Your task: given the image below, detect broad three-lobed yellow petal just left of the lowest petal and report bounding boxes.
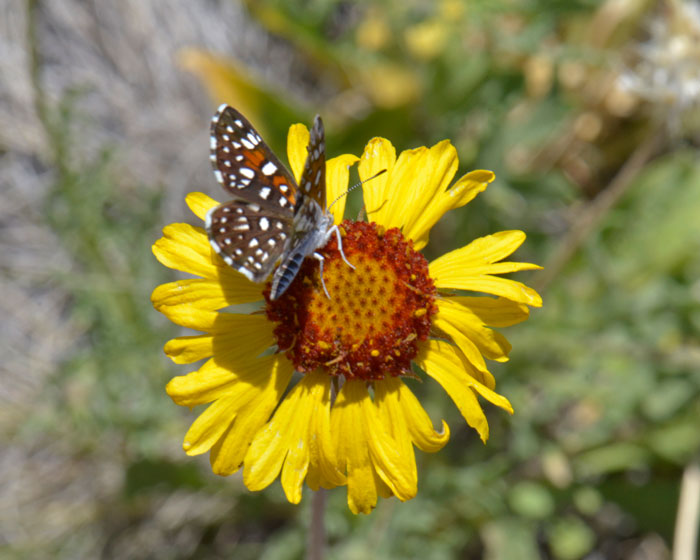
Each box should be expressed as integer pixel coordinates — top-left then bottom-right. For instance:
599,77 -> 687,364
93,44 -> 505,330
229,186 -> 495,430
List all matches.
243,372 -> 345,504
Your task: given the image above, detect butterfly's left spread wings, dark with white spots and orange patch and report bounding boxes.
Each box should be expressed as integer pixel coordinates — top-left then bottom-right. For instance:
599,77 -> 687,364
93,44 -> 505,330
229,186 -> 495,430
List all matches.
206,105 -> 297,282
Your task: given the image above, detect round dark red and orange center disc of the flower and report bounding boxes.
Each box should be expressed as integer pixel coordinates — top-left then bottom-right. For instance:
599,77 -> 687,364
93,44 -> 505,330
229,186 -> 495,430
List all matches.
264,220 -> 437,380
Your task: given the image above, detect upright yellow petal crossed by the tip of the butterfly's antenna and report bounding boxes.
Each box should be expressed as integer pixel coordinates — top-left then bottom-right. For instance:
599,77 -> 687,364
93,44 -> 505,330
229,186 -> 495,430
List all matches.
358,138 -> 396,224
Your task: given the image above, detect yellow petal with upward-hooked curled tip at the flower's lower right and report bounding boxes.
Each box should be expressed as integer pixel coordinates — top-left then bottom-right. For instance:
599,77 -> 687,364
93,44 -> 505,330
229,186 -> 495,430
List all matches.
374,377 -> 450,453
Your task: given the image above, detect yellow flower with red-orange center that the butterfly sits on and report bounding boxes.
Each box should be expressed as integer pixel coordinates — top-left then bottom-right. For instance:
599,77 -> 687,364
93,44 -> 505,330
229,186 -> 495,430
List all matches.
152,121 -> 541,513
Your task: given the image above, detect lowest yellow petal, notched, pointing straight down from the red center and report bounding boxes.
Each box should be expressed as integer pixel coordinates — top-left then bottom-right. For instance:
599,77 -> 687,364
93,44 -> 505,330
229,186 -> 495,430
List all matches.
331,380 -> 416,513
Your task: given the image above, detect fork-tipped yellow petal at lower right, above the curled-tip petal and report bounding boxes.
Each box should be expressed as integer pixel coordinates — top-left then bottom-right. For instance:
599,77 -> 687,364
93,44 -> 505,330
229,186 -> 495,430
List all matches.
415,340 -> 513,442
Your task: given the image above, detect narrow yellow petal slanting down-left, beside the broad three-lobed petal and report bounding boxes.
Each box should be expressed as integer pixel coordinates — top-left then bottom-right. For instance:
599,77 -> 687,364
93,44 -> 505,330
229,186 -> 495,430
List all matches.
210,355 -> 294,476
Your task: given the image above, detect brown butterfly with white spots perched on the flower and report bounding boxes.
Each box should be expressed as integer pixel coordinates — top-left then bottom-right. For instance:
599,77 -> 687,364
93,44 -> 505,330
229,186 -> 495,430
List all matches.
205,104 -> 355,300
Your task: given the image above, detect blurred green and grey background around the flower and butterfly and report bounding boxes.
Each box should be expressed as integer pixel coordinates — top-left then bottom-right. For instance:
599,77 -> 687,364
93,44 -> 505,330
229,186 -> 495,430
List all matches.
0,0 -> 700,560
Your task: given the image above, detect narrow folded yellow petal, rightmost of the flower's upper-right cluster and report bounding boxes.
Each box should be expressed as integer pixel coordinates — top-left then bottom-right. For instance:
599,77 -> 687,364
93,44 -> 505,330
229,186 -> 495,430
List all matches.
404,170 -> 495,250
